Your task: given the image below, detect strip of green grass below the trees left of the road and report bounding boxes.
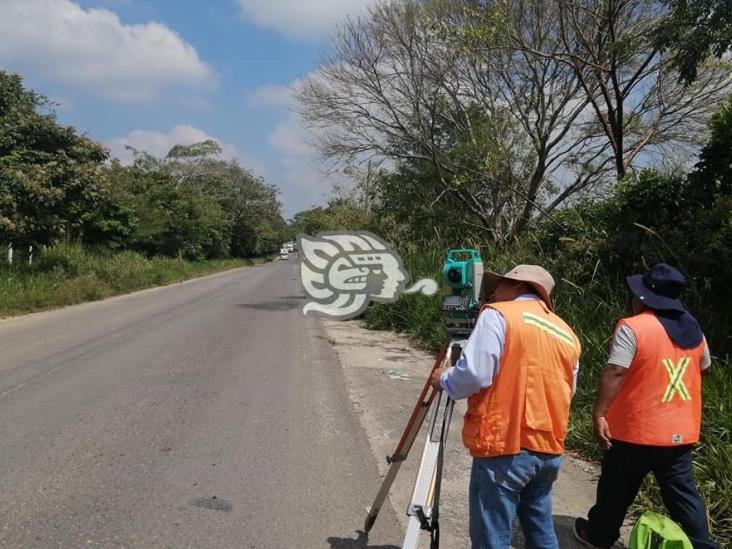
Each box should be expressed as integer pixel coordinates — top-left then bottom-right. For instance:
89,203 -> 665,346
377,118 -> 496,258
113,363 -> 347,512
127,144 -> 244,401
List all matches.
0,244 -> 269,317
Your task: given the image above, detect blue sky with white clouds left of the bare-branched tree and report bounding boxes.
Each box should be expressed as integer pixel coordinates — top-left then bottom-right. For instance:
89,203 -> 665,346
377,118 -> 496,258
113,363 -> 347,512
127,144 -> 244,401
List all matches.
0,0 -> 373,217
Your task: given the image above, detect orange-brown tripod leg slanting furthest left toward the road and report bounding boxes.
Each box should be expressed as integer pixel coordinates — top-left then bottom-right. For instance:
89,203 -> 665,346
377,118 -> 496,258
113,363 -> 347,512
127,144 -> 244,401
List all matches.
364,346 -> 448,534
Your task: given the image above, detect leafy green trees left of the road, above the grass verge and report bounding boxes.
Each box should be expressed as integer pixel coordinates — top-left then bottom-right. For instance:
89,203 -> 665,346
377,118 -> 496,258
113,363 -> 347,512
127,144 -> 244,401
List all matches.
0,71 -> 286,261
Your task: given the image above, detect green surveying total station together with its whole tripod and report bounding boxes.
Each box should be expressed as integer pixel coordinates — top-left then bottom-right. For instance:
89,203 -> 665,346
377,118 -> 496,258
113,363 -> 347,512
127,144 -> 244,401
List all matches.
364,249 -> 483,549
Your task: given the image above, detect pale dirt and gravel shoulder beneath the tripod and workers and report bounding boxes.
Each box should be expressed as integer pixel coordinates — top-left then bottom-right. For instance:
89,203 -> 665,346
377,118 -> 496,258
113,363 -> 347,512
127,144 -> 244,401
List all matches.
323,320 -> 632,549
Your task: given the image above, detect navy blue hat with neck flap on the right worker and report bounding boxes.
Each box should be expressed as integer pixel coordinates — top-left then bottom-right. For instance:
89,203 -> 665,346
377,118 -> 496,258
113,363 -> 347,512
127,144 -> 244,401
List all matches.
626,263 -> 704,349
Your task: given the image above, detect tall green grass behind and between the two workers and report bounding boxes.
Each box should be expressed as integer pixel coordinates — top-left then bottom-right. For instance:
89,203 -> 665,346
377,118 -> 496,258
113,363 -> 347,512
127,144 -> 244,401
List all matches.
364,243 -> 732,547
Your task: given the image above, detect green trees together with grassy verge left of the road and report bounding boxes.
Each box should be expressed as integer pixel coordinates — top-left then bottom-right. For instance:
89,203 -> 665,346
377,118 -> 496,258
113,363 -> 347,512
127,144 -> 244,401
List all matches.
0,71 -> 289,316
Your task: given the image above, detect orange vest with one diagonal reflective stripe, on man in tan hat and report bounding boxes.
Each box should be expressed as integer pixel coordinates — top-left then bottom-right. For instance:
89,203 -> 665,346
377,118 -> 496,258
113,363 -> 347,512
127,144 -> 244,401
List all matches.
462,300 -> 581,457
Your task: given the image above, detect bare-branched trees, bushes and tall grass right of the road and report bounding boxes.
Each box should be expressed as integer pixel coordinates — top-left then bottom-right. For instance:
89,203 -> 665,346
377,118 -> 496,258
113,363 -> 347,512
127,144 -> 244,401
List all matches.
293,0 -> 732,547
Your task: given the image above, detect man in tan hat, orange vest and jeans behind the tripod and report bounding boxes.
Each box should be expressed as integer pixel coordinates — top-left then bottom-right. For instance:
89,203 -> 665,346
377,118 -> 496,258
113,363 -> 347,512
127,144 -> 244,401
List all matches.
432,265 -> 580,549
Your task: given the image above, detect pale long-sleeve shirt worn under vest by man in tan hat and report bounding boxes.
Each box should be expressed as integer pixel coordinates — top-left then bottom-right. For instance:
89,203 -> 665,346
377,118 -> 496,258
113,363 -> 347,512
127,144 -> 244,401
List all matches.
440,294 -> 579,400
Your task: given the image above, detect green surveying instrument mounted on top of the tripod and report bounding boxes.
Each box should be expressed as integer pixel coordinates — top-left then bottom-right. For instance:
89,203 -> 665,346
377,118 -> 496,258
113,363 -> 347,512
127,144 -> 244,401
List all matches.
442,248 -> 483,336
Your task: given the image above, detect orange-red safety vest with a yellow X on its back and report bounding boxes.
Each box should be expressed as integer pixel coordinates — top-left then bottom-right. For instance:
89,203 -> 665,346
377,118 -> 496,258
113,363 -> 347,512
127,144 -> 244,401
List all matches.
607,311 -> 704,446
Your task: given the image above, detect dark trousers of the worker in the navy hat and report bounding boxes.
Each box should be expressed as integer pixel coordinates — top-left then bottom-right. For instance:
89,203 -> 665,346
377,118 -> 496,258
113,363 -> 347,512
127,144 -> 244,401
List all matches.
588,440 -> 718,549
